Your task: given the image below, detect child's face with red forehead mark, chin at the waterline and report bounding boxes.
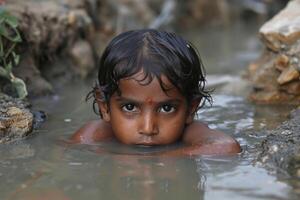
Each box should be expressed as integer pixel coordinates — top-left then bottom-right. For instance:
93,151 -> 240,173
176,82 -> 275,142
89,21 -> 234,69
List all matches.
99,72 -> 197,145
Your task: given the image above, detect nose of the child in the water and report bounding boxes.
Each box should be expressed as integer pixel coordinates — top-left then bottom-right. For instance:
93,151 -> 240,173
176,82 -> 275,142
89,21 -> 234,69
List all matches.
139,112 -> 158,136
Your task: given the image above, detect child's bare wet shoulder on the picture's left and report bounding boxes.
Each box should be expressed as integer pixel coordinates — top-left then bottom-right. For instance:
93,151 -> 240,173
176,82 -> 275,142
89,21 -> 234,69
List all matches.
70,120 -> 113,144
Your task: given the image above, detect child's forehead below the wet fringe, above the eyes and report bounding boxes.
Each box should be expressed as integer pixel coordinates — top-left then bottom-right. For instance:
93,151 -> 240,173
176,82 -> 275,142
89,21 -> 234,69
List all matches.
115,72 -> 184,101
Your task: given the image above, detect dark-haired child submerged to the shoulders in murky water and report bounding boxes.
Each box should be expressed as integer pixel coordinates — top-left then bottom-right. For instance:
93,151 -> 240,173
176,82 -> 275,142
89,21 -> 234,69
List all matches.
71,29 -> 241,155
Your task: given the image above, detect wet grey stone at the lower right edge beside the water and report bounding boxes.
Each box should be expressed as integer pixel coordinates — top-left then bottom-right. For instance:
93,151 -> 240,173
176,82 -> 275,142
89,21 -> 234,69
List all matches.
257,108 -> 300,180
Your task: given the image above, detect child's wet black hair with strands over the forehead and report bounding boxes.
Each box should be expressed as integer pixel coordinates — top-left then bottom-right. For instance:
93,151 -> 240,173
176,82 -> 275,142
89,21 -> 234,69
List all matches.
87,29 -> 212,116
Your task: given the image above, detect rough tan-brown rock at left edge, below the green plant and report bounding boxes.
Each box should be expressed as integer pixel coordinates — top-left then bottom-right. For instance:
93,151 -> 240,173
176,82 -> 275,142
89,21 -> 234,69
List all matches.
0,93 -> 33,143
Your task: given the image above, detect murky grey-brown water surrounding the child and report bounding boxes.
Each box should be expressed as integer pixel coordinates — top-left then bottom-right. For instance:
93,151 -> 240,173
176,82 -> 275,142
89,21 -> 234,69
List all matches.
0,21 -> 297,200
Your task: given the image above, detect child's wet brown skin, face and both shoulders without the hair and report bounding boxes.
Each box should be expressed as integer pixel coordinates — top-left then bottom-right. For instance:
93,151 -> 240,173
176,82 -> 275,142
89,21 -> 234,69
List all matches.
71,72 -> 241,155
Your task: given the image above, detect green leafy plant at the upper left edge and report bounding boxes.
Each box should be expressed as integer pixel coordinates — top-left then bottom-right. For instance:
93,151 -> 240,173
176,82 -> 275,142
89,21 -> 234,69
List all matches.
0,7 -> 28,99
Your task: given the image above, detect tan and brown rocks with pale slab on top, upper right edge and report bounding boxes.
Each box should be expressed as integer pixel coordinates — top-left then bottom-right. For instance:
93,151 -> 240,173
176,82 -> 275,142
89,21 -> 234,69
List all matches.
249,0 -> 300,105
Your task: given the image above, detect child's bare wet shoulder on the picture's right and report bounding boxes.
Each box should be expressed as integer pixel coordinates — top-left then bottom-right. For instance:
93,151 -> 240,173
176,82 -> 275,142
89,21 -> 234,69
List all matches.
183,121 -> 241,155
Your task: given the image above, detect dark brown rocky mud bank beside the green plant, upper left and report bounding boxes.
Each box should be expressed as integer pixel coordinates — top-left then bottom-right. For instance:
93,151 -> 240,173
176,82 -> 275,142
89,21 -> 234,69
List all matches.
6,0 -> 100,97
